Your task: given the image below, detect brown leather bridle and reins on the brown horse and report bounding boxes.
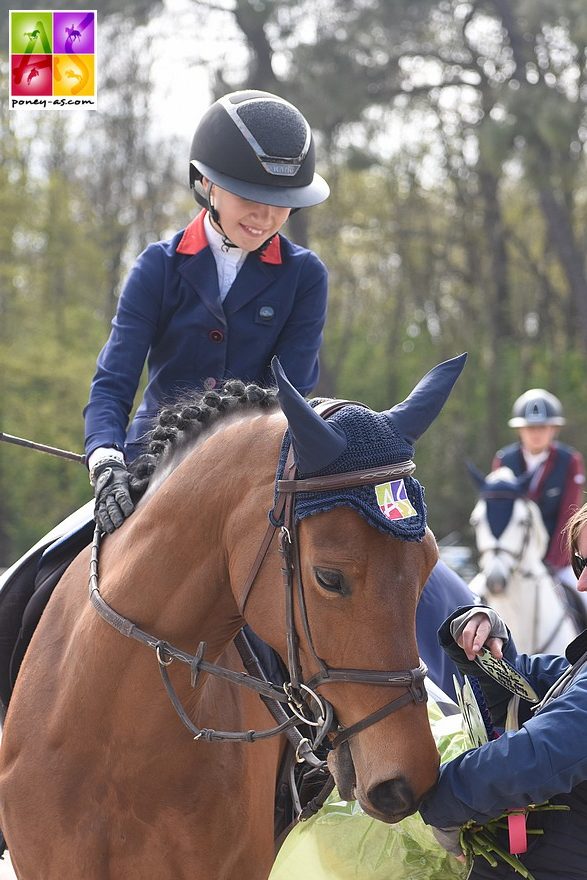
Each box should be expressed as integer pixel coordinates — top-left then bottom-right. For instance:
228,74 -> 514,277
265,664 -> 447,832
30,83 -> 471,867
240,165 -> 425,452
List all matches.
89,400 -> 428,766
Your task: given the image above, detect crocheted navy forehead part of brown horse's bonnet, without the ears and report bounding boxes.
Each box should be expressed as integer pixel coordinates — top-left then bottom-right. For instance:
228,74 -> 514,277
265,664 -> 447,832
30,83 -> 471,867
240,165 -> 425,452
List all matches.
276,408 -> 426,541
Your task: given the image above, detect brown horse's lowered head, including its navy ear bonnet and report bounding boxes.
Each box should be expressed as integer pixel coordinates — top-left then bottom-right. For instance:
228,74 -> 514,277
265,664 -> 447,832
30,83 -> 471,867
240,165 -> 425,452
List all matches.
234,356 -> 465,822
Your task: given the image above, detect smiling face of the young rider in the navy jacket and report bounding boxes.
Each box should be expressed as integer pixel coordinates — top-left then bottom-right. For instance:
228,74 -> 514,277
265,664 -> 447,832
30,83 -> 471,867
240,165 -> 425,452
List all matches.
202,178 -> 290,251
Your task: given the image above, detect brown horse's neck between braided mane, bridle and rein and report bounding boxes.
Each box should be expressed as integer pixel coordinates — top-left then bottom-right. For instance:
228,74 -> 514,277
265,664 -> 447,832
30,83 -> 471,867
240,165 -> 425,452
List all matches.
100,416 -> 279,653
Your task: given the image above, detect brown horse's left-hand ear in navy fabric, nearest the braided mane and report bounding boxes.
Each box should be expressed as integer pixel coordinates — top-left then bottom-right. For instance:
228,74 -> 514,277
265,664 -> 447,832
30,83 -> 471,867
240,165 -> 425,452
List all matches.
271,357 -> 347,474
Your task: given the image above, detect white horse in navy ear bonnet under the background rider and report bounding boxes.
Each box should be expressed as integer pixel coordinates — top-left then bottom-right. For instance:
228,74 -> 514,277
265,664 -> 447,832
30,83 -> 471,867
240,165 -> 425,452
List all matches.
469,467 -> 580,654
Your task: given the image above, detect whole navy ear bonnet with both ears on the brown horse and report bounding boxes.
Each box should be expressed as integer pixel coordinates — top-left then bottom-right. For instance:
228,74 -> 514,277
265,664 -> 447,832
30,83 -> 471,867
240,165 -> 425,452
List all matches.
271,354 -> 467,541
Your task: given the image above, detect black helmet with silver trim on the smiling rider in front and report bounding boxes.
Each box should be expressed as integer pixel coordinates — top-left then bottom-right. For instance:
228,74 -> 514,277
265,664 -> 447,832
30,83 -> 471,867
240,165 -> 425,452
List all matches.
190,90 -> 330,209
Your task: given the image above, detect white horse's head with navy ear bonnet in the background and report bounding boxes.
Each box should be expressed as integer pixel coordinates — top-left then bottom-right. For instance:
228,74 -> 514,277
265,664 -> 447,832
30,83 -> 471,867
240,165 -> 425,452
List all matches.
469,465 -> 548,595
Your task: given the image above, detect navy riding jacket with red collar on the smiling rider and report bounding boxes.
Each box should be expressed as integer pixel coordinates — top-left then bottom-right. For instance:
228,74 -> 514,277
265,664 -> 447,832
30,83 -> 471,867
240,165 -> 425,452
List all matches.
84,211 -> 327,458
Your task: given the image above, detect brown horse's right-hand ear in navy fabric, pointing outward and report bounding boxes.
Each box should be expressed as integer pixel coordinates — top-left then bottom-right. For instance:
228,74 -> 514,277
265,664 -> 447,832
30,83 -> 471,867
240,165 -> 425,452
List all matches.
387,354 -> 467,443
